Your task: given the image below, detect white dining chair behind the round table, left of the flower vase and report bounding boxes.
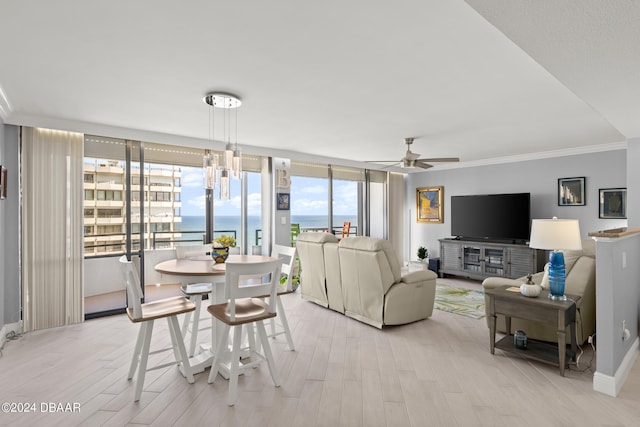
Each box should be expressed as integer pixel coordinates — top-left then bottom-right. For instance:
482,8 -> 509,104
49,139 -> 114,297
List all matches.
176,245 -> 213,357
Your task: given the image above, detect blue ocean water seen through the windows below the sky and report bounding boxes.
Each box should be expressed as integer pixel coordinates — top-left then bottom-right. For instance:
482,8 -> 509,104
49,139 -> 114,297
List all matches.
176,215 -> 358,245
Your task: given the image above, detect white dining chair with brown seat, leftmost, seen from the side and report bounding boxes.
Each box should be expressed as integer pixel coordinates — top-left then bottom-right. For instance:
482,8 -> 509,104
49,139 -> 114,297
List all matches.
120,255 -> 196,402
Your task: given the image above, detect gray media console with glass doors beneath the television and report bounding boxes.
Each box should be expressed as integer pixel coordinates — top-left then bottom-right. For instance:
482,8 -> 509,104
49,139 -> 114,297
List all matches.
440,239 -> 547,280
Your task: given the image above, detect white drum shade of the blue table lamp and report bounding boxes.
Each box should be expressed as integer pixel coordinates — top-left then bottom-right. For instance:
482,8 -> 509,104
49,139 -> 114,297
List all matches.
529,218 -> 582,250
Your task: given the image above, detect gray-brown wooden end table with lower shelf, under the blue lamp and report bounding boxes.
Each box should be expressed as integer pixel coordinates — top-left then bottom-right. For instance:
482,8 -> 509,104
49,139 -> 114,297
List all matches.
485,286 -> 581,376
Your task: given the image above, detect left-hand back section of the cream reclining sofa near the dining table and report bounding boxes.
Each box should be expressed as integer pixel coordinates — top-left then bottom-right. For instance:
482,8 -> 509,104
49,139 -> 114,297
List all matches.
296,233 -> 344,312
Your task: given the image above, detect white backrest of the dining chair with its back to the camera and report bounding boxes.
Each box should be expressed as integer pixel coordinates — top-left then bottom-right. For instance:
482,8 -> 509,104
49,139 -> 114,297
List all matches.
224,259 -> 282,321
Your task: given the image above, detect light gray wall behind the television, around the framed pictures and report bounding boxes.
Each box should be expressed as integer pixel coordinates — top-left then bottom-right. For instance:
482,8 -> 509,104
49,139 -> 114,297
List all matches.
404,150 -> 627,260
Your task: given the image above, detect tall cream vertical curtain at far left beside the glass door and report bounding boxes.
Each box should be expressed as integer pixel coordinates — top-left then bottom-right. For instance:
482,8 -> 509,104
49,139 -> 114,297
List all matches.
21,127 -> 84,331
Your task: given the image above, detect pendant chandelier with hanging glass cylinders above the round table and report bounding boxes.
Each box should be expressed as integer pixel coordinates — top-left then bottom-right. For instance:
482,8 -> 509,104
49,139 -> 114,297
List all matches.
202,92 -> 242,200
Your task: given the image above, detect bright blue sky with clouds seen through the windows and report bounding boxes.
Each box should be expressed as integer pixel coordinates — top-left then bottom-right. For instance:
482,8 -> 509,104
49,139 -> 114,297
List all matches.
182,168 -> 358,216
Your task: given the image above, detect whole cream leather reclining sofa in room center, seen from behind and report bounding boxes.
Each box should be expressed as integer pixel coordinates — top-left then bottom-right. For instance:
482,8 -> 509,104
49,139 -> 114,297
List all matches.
296,233 -> 437,328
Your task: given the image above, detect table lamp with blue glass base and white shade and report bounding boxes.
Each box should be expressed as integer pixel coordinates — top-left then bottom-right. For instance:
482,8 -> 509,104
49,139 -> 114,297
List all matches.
529,217 -> 582,301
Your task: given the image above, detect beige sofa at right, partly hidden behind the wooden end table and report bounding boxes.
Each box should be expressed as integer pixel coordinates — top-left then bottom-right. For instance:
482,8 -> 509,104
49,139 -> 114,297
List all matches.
482,239 -> 596,345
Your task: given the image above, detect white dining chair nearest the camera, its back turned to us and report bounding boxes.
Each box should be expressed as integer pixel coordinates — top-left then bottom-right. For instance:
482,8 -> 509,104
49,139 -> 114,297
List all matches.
207,260 -> 282,406
